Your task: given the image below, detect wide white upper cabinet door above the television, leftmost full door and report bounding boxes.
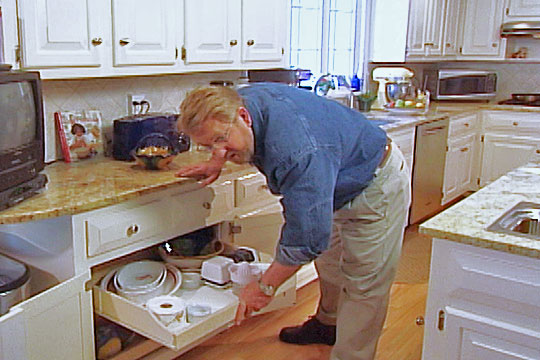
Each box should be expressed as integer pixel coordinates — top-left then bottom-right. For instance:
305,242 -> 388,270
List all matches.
18,0 -> 105,68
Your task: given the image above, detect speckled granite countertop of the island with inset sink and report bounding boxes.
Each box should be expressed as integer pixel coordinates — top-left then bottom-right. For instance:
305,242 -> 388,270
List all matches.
420,163 -> 540,259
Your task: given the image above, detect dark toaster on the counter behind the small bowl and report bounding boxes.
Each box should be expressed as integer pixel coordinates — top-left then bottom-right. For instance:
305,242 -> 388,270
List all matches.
113,114 -> 190,161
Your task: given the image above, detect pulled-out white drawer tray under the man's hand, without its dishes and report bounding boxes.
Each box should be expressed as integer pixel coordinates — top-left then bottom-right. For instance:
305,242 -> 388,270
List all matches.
93,260 -> 296,353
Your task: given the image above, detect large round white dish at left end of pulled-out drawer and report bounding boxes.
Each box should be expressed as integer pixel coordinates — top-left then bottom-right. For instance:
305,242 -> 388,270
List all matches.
114,260 -> 167,291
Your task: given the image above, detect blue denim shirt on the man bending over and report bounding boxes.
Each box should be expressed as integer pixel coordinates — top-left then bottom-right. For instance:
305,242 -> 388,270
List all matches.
239,83 -> 386,265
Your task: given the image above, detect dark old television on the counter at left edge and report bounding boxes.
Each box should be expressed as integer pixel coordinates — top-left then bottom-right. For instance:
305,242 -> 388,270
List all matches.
0,65 -> 47,209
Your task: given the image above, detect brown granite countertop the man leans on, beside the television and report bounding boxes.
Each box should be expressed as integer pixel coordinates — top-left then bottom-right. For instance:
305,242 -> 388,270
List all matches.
0,151 -> 251,224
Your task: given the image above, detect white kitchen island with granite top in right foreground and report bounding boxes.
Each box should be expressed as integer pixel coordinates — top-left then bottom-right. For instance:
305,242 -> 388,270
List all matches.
420,163 -> 540,360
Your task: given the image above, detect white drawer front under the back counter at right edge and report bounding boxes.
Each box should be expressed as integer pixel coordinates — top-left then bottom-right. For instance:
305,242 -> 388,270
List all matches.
483,111 -> 540,135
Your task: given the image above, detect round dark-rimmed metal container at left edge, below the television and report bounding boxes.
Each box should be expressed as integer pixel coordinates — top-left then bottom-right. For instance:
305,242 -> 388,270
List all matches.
0,254 -> 30,315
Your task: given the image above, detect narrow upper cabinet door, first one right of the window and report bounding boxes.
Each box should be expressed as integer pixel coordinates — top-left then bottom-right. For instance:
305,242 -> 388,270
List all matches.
407,0 -> 445,56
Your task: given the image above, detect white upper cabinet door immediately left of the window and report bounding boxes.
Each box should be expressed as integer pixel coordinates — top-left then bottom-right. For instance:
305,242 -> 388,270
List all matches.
242,0 -> 288,63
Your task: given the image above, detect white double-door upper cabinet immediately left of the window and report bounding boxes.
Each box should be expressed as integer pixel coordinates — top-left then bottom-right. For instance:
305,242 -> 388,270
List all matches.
182,0 -> 288,67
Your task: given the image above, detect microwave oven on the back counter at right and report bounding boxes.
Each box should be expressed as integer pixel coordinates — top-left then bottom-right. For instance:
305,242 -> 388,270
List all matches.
424,69 -> 497,101
